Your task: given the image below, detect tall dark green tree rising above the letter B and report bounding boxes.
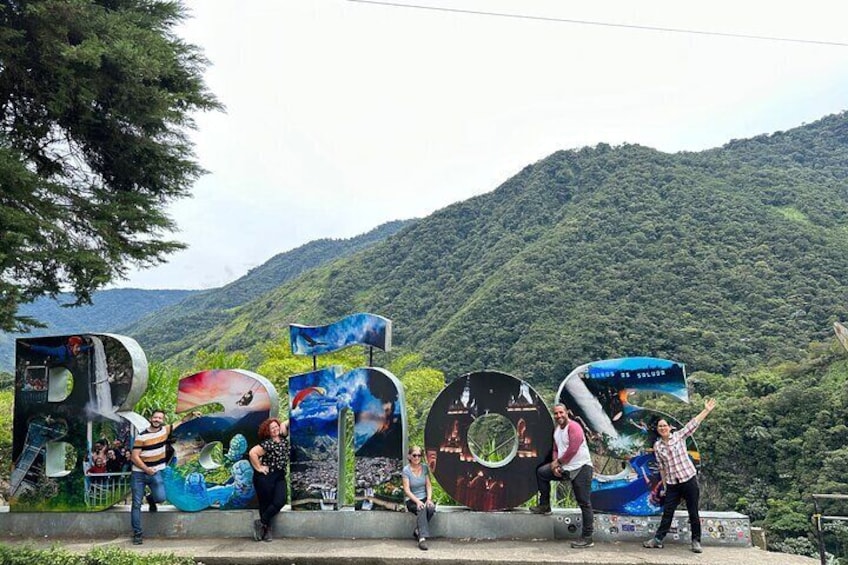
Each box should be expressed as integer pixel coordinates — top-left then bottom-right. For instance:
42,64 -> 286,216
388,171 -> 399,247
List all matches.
0,0 -> 221,331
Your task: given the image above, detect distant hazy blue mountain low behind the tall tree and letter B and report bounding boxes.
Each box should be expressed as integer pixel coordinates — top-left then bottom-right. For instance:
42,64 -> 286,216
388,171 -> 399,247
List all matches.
0,288 -> 198,371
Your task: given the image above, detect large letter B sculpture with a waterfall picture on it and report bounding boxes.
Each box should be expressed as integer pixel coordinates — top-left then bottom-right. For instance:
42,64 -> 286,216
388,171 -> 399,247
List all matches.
10,334 -> 147,512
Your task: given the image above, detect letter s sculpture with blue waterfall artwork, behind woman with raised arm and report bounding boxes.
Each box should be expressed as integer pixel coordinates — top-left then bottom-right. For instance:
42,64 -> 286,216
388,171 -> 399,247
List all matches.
557,357 -> 700,516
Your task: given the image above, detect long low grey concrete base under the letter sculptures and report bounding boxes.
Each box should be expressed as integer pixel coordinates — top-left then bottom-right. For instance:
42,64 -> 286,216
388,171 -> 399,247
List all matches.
0,505 -> 751,547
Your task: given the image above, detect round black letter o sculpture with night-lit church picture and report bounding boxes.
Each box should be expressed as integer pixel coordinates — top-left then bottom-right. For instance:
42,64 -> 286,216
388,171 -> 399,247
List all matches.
424,371 -> 553,511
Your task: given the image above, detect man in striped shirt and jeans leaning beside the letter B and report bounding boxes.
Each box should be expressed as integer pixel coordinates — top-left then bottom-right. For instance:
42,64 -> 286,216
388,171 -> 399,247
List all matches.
130,410 -> 198,545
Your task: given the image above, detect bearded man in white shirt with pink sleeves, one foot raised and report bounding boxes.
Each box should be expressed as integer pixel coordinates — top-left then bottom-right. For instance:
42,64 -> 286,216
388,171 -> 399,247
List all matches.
530,404 -> 595,548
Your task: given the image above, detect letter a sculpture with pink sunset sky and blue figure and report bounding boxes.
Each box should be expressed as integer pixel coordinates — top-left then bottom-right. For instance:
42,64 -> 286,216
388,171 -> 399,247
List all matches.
164,369 -> 279,512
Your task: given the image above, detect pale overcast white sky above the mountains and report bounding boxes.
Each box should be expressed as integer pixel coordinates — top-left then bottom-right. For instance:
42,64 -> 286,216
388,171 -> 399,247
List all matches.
117,0 -> 848,288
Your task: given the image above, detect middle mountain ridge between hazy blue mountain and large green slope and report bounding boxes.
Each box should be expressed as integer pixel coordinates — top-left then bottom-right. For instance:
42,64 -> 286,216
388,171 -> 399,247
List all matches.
121,220 -> 416,359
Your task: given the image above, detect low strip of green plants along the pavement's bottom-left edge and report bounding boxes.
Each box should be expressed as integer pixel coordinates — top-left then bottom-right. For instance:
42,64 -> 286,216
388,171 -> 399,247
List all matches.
0,542 -> 195,565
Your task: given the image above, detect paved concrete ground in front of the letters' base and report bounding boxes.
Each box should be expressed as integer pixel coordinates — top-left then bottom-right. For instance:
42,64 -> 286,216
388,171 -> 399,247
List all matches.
0,536 -> 818,565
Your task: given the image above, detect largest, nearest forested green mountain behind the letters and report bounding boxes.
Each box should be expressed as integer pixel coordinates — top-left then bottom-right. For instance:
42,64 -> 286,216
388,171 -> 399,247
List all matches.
154,113 -> 848,388
